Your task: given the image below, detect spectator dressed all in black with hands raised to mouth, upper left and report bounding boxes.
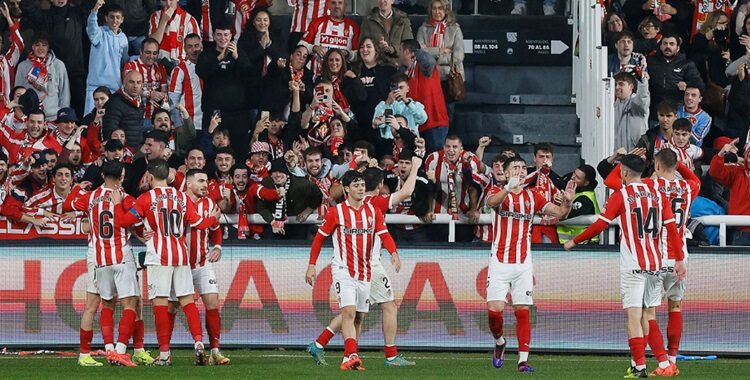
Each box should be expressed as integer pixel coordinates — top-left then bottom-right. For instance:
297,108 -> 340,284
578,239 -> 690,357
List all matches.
195,24 -> 255,157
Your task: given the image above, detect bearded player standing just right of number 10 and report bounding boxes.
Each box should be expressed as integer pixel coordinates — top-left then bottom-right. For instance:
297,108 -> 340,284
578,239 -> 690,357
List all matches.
185,169 -> 229,365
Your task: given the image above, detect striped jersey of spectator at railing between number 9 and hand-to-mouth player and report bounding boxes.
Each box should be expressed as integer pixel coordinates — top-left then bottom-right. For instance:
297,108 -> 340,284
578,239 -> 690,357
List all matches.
424,150 -> 489,214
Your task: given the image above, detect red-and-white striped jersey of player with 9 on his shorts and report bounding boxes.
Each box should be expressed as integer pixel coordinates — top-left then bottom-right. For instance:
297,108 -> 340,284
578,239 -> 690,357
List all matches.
318,201 -> 388,282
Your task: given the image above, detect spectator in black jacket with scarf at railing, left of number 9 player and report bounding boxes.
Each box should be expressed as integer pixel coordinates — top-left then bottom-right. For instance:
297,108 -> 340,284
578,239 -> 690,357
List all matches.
258,160 -> 323,239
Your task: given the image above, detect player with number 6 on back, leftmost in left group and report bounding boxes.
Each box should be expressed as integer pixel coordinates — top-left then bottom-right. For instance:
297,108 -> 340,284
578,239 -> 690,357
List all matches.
67,161 -> 140,367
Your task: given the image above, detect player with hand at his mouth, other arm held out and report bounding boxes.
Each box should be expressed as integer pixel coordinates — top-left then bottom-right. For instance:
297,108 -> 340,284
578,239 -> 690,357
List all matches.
486,157 -> 575,372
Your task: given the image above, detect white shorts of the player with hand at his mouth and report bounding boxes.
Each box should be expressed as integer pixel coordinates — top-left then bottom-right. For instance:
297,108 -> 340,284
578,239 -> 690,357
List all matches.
487,255 -> 534,305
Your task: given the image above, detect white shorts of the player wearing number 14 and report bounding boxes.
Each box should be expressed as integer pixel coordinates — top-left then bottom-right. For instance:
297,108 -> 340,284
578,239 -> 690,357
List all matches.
620,269 -> 661,309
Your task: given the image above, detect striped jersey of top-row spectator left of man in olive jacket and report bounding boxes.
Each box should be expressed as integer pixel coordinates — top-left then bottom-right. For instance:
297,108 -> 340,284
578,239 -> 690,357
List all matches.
300,16 -> 359,77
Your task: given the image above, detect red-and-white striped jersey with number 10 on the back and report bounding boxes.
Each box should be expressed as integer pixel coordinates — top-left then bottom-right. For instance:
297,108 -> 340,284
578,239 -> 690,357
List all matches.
125,187 -> 217,266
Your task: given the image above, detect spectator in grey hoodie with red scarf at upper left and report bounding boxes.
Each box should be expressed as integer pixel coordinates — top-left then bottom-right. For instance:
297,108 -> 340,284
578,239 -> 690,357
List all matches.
15,34 -> 70,120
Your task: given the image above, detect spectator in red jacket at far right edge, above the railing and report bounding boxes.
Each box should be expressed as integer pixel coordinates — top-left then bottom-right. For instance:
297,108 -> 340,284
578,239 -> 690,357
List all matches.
709,139 -> 750,246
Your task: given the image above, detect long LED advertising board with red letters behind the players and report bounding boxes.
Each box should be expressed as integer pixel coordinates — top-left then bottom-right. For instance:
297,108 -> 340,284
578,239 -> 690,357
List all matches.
0,241 -> 750,355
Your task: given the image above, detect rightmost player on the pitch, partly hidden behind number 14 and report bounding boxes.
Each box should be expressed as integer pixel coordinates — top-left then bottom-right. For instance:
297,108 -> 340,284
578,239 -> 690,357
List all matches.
604,149 -> 701,375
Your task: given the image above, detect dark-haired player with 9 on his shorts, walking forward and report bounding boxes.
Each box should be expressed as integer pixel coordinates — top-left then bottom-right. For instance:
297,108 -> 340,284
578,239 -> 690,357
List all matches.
305,170 -> 401,371
